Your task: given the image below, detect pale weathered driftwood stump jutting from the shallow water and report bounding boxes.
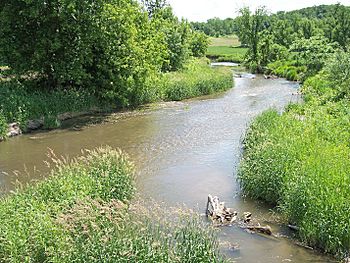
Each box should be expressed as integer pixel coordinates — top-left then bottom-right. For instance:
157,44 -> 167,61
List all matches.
206,195 -> 237,225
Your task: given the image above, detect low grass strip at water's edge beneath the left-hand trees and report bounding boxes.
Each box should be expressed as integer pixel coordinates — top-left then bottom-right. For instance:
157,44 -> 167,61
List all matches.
0,59 -> 233,141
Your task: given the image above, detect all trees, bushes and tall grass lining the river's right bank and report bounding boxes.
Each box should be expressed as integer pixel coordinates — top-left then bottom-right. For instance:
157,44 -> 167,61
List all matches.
239,5 -> 350,257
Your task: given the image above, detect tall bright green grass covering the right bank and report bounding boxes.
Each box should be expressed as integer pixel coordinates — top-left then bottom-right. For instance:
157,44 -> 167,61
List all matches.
239,53 -> 350,257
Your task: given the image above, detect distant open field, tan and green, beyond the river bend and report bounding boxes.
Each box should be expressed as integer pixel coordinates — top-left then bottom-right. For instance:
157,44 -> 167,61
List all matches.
206,36 -> 248,63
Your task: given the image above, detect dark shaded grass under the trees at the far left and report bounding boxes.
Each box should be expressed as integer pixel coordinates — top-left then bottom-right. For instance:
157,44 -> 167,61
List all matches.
0,80 -> 102,130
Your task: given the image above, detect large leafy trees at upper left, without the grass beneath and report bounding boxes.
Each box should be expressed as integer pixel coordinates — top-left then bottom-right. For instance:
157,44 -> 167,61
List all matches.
0,0 -> 208,105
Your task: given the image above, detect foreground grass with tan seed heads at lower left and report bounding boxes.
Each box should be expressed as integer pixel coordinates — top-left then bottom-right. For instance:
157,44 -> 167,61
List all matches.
0,148 -> 223,262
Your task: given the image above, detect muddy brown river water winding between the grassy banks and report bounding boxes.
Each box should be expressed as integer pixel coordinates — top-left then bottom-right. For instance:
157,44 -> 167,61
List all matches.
0,75 -> 334,263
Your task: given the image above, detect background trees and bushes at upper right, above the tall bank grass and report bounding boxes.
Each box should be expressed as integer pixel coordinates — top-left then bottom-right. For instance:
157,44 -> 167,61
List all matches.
236,4 -> 350,75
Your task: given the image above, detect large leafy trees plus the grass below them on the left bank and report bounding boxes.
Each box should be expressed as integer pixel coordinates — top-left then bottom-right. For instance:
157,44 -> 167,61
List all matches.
0,0 -> 232,137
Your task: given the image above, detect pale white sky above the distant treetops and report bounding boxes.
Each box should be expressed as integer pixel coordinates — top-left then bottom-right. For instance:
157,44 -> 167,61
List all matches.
168,0 -> 350,22
